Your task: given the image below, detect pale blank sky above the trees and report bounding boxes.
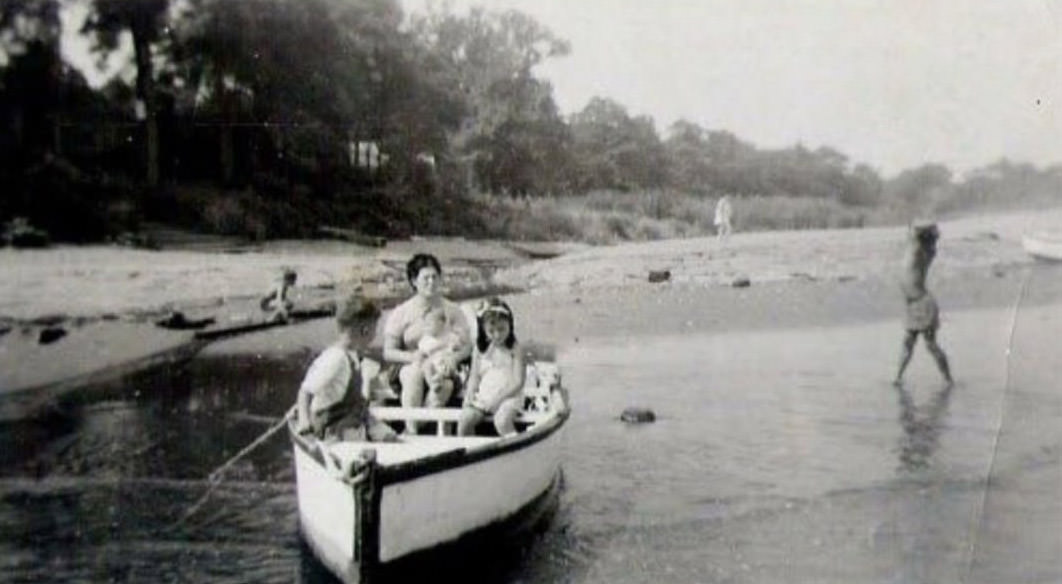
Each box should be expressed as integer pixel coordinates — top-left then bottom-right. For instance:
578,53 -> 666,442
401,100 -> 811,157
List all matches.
402,0 -> 1062,175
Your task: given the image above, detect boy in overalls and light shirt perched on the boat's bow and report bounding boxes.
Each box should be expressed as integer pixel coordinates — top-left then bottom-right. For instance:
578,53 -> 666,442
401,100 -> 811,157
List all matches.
295,297 -> 398,442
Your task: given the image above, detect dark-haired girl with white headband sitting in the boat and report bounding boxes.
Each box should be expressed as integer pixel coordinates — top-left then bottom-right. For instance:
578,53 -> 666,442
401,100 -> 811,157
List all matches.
458,298 -> 527,436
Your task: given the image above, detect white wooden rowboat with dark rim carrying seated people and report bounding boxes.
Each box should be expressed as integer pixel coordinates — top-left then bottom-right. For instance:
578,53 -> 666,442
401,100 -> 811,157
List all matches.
288,362 -> 569,584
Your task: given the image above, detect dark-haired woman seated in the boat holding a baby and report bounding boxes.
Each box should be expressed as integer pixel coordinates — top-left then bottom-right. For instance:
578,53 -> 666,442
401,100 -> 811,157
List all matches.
383,254 -> 472,433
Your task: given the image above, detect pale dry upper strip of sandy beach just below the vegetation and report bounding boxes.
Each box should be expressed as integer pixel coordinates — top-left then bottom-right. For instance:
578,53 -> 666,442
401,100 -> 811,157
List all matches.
0,209 -> 1062,323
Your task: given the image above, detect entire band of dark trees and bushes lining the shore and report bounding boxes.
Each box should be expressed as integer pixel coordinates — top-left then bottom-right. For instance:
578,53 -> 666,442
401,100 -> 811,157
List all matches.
0,0 -> 1062,241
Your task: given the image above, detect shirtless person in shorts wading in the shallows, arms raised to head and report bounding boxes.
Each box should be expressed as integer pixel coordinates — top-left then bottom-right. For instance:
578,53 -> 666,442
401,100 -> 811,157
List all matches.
893,223 -> 953,385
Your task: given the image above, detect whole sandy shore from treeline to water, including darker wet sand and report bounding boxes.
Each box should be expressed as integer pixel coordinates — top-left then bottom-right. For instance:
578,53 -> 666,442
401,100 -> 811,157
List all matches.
0,209 -> 1062,405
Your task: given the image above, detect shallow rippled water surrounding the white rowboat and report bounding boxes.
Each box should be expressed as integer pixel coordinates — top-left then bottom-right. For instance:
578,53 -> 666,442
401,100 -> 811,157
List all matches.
0,273 -> 1062,583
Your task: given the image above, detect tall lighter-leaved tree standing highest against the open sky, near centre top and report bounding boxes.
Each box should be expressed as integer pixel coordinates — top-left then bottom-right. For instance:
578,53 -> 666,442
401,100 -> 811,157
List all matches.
412,8 -> 569,193
